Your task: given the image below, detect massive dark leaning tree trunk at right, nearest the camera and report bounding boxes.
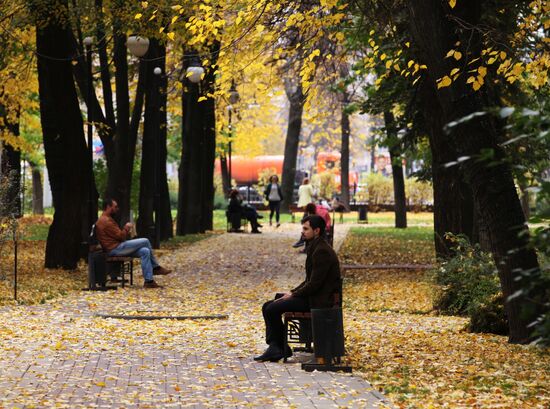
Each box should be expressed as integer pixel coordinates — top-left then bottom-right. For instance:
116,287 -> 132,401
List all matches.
409,0 -> 544,343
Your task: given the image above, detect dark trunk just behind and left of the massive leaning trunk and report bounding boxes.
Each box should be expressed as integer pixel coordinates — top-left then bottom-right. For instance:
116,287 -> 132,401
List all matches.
419,81 -> 478,259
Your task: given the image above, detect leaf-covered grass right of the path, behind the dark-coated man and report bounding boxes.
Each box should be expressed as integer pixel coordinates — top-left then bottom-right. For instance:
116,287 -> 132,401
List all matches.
341,228 -> 550,408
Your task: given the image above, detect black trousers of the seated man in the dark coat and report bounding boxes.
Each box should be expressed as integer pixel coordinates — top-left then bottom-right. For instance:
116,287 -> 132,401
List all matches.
262,294 -> 310,349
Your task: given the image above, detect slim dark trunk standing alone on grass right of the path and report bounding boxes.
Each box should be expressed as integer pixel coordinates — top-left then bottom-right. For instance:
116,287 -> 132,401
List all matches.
384,111 -> 407,229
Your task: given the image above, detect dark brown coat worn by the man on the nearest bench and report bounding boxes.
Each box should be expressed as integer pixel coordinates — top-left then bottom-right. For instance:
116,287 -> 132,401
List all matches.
291,238 -> 342,308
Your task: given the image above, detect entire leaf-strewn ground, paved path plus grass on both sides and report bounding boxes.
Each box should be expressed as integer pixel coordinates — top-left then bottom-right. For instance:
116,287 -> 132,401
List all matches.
0,215 -> 550,408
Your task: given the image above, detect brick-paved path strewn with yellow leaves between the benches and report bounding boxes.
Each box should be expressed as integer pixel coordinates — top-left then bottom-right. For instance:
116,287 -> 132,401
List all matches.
0,225 -> 396,409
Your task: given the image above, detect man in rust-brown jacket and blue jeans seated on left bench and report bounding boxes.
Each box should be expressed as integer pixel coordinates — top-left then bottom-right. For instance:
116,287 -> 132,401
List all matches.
95,199 -> 171,288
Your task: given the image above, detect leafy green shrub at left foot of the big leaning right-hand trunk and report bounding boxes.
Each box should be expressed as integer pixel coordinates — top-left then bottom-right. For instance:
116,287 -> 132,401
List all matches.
433,234 -> 508,334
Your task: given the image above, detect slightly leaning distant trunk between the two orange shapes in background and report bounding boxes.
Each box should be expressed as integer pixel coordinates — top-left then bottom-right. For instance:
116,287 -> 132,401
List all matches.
281,81 -> 304,212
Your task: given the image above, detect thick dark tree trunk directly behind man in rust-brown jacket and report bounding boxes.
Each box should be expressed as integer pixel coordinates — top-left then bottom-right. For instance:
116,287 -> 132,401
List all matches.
36,0 -> 97,269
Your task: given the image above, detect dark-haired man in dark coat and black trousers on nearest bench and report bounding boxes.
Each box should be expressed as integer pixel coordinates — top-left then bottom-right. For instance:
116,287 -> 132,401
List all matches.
254,215 -> 341,362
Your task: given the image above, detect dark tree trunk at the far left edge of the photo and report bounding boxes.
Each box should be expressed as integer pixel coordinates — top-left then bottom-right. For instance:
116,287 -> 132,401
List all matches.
0,105 -> 21,217
